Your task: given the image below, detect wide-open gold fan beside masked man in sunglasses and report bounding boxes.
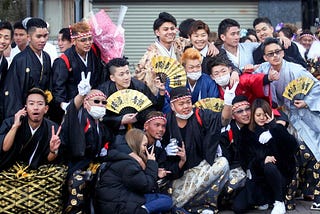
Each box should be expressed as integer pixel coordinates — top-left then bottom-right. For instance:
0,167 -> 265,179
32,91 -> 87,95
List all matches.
107,89 -> 152,114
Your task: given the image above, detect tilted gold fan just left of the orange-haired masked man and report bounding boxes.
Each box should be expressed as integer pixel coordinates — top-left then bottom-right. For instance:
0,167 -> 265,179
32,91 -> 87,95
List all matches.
151,56 -> 187,88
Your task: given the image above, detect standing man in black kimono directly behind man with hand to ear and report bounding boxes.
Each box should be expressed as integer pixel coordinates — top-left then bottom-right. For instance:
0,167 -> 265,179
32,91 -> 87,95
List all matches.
4,18 -> 51,121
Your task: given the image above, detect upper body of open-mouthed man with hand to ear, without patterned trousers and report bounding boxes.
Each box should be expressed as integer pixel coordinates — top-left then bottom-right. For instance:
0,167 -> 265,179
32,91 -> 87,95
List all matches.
0,88 -> 61,170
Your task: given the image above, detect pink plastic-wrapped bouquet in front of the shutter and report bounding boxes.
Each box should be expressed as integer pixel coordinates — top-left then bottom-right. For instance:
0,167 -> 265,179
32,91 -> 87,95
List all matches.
88,6 -> 128,63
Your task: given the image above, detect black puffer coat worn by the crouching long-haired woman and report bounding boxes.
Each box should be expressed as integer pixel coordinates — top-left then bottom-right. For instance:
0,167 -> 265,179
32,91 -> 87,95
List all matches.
95,150 -> 158,214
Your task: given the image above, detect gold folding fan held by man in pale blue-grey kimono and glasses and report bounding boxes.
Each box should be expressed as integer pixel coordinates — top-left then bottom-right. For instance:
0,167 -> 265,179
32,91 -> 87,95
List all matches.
282,77 -> 314,100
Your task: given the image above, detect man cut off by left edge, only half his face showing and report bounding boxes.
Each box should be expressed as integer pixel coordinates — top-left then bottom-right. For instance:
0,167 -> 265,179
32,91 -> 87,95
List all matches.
0,21 -> 13,124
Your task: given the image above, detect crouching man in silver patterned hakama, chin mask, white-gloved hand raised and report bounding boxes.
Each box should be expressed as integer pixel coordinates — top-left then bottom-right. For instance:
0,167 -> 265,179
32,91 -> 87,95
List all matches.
163,84 -> 237,213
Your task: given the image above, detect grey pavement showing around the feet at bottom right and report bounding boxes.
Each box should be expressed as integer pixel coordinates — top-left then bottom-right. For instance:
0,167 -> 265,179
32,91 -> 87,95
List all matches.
219,200 -> 320,214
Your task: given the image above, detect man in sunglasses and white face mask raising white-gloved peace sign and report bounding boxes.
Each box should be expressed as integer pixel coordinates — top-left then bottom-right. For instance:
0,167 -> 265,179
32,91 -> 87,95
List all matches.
62,72 -> 110,213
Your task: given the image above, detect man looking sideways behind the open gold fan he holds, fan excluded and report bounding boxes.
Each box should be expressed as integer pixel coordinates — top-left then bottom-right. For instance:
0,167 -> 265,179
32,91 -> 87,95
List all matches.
98,58 -> 165,135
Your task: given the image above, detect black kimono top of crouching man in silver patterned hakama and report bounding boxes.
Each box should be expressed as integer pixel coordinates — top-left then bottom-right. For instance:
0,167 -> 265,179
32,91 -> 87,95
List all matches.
163,109 -> 222,179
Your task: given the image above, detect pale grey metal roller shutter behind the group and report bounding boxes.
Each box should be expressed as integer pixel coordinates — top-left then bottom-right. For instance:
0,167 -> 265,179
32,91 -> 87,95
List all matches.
93,1 -> 258,68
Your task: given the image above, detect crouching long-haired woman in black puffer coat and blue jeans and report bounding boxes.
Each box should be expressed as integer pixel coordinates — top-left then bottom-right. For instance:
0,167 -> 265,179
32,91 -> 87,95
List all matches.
95,129 -> 172,214
